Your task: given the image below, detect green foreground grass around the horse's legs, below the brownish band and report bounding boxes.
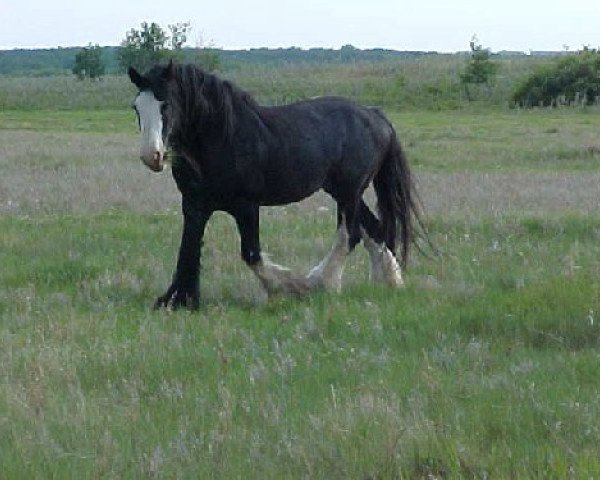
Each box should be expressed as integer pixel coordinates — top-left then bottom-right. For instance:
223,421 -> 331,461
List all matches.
0,212 -> 600,478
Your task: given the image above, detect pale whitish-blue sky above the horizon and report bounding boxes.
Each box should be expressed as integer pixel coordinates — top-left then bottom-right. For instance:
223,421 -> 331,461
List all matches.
0,0 -> 600,52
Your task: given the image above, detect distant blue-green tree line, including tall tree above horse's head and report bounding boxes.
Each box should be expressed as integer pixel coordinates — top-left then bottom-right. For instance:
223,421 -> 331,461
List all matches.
0,22 -> 446,79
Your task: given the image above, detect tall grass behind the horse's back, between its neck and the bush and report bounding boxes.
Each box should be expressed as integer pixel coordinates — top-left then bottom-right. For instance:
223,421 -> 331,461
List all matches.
234,55 -> 540,110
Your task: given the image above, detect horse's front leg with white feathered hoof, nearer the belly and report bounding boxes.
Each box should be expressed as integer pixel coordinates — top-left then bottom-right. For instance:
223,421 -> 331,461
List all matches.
229,201 -> 310,295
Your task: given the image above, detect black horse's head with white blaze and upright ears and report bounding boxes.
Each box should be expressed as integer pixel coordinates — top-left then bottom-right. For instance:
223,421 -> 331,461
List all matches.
128,61 -> 175,172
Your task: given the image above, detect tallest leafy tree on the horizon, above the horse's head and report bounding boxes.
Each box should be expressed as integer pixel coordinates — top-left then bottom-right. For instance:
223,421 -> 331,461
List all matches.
118,22 -> 190,71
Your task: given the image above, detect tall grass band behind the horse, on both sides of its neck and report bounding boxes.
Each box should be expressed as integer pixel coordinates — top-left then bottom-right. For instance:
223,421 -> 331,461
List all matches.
0,55 -> 540,110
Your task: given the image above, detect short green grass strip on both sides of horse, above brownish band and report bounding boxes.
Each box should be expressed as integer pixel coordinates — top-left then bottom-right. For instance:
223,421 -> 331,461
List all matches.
0,108 -> 600,173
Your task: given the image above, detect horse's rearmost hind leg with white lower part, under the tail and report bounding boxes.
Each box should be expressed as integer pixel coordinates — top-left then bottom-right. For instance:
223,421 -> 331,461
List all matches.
359,199 -> 404,287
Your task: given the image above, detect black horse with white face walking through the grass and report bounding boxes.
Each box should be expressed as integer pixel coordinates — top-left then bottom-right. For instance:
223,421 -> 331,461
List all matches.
128,60 -> 422,310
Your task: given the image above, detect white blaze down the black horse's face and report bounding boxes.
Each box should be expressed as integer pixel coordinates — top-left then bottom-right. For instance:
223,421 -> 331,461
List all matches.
134,91 -> 165,172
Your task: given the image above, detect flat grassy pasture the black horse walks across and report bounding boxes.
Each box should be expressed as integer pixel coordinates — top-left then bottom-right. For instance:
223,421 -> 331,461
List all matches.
0,103 -> 600,479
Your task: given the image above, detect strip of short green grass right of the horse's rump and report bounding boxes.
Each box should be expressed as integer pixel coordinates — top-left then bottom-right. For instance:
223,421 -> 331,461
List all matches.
391,109 -> 600,172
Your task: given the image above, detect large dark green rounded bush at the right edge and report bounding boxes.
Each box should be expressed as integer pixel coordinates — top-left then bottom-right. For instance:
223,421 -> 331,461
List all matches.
512,49 -> 600,107
